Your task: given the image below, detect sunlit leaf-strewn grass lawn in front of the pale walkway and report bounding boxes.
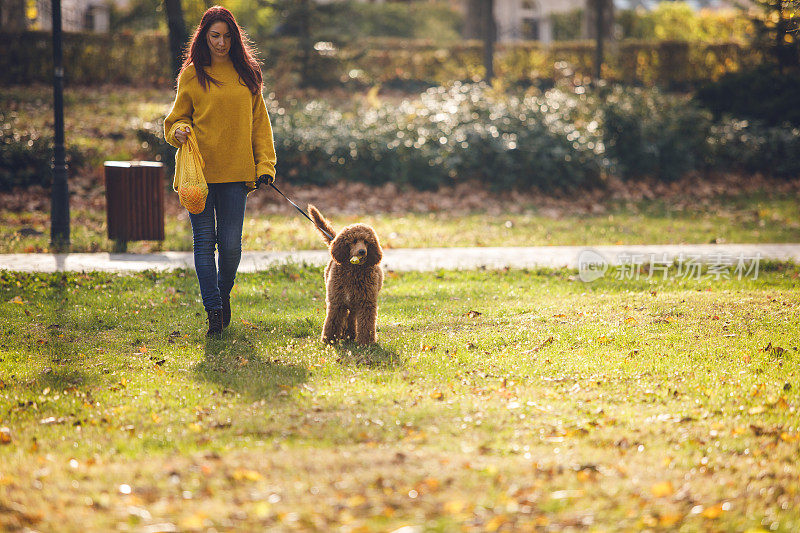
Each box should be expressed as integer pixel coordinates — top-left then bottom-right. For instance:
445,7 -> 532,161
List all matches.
0,265 -> 800,531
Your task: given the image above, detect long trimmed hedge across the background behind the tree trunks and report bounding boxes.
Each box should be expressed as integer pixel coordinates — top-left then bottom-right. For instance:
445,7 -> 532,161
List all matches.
0,32 -> 762,87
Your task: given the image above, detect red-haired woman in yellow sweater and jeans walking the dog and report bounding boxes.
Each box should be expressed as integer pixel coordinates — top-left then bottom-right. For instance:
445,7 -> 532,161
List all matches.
164,6 -> 276,335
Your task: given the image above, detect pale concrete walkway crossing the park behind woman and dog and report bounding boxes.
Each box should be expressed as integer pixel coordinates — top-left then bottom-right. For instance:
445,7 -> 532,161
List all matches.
0,244 -> 800,272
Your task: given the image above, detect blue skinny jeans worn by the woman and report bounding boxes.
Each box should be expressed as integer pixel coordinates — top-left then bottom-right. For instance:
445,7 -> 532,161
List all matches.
189,182 -> 247,310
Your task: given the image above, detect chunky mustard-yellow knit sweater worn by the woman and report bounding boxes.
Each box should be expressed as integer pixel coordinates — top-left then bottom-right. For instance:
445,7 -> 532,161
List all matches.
164,60 -> 276,187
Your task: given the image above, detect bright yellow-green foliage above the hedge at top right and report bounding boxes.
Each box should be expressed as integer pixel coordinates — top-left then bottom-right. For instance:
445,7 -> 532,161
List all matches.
617,2 -> 753,43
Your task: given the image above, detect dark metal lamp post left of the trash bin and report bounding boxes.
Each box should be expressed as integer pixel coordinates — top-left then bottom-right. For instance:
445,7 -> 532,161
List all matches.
50,0 -> 69,250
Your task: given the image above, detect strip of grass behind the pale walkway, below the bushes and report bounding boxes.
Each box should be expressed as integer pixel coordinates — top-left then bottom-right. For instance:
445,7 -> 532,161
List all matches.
0,191 -> 800,253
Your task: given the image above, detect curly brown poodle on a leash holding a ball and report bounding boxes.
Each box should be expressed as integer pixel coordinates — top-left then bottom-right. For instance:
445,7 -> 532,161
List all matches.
308,205 -> 383,344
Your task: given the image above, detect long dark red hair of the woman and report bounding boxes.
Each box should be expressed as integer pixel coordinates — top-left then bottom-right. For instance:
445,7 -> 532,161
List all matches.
178,6 -> 264,94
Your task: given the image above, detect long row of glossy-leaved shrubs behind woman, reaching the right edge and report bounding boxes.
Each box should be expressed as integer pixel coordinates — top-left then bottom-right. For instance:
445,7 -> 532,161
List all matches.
133,83 -> 800,190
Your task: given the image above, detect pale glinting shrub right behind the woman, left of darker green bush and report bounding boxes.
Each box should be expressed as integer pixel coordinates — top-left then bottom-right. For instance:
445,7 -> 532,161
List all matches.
140,83 -> 601,190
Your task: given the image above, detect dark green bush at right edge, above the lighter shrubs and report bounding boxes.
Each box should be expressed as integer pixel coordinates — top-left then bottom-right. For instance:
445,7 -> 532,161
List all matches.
695,66 -> 800,126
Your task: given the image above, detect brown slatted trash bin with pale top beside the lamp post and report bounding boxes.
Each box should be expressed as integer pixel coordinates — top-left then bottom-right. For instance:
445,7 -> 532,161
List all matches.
104,161 -> 164,252
